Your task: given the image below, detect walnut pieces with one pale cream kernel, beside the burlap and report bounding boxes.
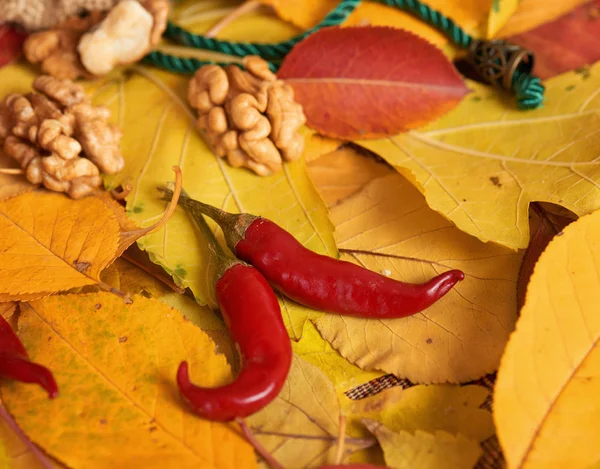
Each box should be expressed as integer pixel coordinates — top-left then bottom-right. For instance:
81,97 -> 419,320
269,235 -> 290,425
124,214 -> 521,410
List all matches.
23,0 -> 170,80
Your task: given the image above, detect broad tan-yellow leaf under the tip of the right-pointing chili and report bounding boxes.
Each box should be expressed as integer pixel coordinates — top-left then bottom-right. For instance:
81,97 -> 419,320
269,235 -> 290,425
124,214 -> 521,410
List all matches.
315,166 -> 522,383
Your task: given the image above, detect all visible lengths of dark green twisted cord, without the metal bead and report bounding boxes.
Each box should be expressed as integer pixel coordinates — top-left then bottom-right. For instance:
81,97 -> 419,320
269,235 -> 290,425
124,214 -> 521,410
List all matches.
144,0 -> 544,109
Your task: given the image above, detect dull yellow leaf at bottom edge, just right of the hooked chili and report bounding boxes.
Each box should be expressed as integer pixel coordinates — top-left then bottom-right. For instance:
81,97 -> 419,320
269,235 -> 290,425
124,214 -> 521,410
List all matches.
248,355 -> 375,469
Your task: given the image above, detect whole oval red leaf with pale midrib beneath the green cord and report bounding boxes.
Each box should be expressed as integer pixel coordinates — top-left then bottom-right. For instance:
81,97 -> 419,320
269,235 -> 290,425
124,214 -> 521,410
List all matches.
278,27 -> 468,140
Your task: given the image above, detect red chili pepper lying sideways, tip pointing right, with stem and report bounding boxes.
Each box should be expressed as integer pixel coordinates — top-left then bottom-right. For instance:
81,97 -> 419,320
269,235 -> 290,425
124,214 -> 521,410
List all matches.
160,188 -> 465,319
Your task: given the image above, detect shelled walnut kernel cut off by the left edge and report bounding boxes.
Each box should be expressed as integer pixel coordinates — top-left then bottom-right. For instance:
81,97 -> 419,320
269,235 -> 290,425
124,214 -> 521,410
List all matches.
0,75 -> 124,199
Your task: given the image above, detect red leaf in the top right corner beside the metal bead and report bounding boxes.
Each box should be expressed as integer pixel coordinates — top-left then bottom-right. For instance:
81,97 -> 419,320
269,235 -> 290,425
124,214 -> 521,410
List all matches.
508,0 -> 600,79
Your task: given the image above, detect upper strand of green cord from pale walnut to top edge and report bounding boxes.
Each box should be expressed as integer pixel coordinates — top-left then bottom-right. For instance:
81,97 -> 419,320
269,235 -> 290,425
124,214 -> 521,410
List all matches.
164,0 -> 361,60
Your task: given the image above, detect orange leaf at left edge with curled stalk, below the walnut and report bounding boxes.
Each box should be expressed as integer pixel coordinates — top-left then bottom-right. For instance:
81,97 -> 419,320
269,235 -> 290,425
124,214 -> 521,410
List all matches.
0,167 -> 180,301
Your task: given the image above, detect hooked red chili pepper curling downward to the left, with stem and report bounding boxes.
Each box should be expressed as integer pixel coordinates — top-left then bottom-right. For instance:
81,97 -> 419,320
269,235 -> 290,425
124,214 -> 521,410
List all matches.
177,205 -> 292,421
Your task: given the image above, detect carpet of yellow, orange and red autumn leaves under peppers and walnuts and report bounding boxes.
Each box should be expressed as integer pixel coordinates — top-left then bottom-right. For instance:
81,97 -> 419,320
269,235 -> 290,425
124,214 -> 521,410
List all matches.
0,0 -> 600,469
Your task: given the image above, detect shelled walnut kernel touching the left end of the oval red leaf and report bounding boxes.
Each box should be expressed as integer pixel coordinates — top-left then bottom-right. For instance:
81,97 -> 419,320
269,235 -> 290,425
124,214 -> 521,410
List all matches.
188,56 -> 306,176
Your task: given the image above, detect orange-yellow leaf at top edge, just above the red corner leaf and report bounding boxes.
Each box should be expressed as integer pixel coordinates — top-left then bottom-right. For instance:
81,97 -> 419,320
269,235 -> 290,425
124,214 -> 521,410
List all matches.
497,0 -> 589,37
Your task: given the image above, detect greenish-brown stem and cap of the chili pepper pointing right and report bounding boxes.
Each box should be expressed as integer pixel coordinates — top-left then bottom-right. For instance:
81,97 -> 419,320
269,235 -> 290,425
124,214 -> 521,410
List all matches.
158,187 -> 253,252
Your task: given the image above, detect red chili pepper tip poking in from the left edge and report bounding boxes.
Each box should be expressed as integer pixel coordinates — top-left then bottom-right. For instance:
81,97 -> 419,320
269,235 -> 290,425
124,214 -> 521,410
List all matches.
0,316 -> 58,399
